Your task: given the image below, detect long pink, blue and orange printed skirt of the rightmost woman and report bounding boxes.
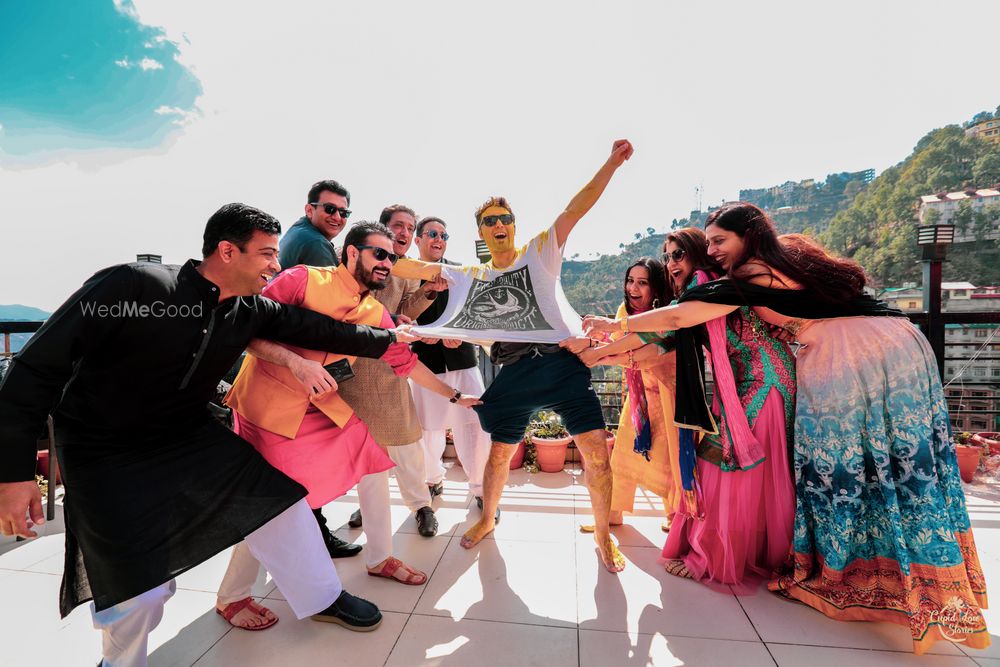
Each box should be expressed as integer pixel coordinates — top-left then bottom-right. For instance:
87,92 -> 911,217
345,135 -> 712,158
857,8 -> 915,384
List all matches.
770,317 -> 990,653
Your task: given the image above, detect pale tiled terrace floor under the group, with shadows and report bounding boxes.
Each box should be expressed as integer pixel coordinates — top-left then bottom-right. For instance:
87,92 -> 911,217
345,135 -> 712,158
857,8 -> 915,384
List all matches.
0,467 -> 1000,667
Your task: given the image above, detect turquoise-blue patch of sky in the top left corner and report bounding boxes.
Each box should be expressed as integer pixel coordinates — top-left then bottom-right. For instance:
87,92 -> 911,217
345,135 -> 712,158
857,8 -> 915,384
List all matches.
0,0 -> 201,157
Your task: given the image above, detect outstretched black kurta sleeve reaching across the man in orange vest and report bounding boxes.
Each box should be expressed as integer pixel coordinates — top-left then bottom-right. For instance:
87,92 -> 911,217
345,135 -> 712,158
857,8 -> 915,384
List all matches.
255,297 -> 392,359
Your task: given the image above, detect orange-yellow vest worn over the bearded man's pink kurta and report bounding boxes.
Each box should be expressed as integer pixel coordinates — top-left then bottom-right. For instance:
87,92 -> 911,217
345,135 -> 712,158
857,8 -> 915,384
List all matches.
226,265 -> 385,438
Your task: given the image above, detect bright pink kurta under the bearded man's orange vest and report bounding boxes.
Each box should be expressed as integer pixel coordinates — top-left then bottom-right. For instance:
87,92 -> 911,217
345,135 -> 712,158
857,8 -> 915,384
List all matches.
233,266 -> 417,508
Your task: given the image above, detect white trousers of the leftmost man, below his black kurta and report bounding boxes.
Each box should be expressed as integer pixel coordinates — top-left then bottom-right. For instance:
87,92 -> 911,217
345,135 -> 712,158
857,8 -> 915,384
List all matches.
97,499 -> 343,667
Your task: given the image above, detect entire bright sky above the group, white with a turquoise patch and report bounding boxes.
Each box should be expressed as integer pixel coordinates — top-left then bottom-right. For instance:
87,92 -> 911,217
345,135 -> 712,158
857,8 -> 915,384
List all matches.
0,0 -> 1000,310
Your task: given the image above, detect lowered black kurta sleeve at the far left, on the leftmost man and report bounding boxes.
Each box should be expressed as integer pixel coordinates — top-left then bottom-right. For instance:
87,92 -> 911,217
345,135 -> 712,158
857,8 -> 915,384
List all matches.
0,265 -> 135,482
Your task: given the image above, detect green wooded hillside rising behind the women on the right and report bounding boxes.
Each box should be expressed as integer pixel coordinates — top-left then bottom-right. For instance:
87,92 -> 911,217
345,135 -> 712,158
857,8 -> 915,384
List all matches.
562,108 -> 1000,315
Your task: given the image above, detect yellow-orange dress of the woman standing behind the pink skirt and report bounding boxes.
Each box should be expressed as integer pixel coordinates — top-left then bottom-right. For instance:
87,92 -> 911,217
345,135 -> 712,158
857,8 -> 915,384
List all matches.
611,304 -> 681,514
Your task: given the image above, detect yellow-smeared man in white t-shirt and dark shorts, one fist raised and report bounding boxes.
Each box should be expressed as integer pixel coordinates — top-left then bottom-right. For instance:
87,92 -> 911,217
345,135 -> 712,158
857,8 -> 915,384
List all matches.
394,140 -> 632,572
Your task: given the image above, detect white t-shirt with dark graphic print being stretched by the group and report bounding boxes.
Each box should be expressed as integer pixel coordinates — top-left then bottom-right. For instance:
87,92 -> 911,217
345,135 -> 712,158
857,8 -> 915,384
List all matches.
415,228 -> 583,343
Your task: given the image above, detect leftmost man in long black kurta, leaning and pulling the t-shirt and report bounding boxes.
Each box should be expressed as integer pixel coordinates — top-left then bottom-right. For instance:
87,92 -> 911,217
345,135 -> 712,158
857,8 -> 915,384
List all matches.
0,204 -> 406,664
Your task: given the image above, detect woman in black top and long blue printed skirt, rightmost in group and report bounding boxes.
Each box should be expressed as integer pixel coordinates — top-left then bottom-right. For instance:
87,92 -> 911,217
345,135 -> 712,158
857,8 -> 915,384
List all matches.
585,203 -> 990,653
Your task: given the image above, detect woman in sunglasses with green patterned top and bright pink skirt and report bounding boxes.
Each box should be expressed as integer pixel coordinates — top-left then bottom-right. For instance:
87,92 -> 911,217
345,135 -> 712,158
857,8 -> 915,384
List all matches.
583,228 -> 795,592
